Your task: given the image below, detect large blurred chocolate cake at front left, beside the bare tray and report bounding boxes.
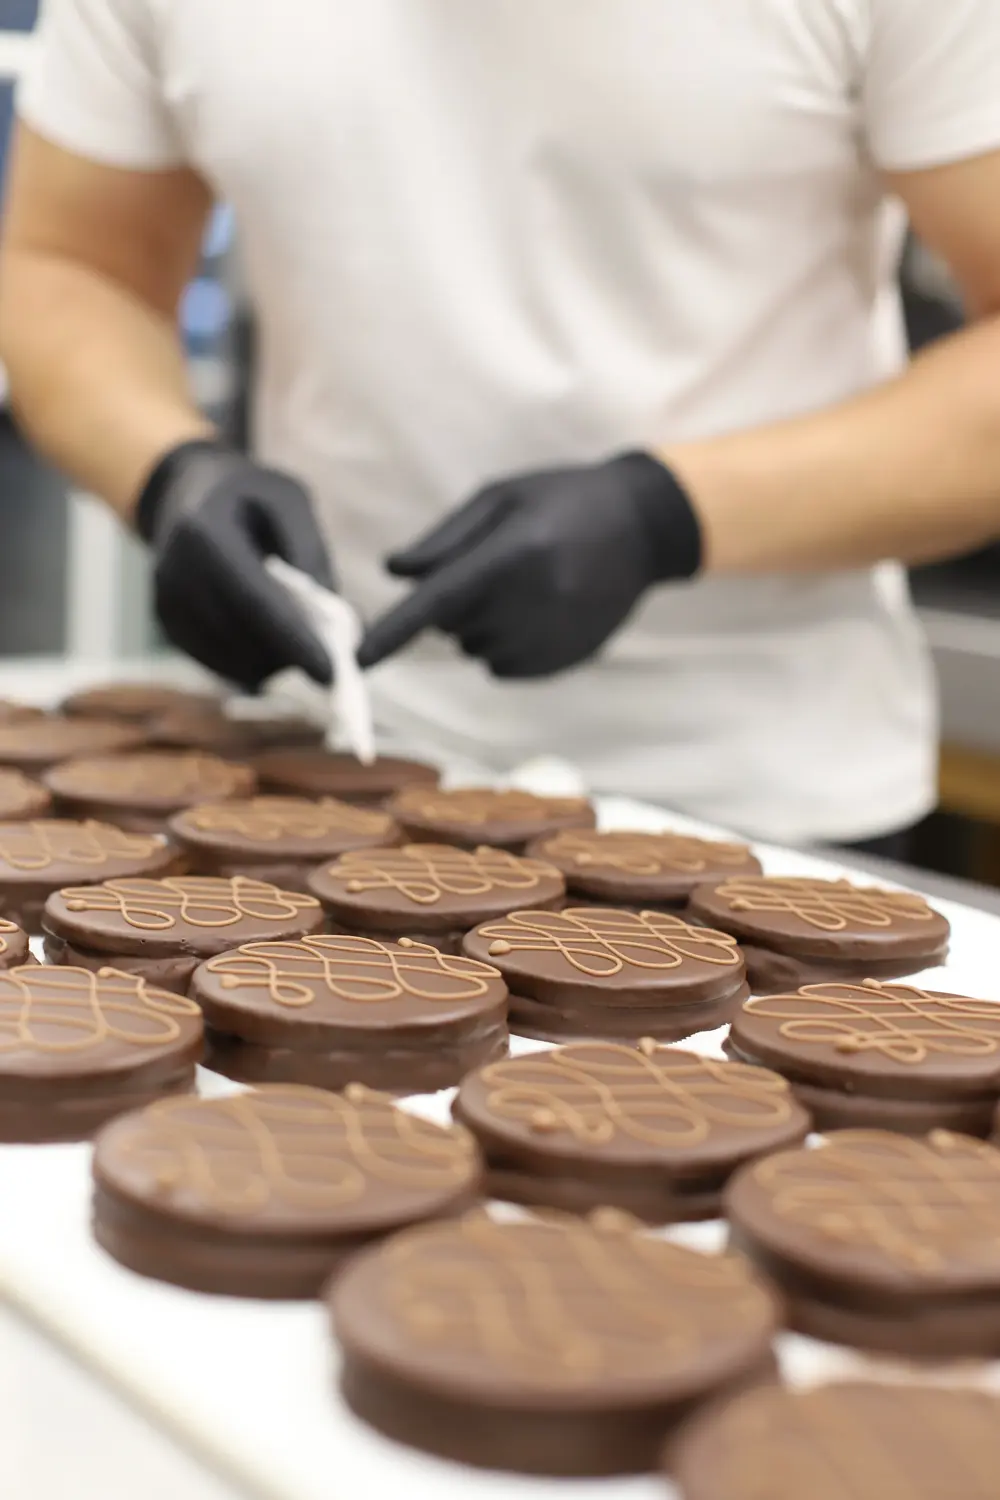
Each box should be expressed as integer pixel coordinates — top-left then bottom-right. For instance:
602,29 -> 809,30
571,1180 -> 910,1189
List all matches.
93,1085 -> 481,1298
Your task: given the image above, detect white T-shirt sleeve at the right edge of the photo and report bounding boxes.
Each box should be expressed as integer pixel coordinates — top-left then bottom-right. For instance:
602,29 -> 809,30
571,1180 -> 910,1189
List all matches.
864,0 -> 1000,171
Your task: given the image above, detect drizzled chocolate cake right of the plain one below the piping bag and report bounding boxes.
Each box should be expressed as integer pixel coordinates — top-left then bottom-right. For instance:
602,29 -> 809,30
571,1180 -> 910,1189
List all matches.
387,786 -> 594,854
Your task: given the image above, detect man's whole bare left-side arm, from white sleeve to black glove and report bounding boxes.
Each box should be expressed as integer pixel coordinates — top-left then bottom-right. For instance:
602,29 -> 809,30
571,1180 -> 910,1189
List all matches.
0,125 -> 211,516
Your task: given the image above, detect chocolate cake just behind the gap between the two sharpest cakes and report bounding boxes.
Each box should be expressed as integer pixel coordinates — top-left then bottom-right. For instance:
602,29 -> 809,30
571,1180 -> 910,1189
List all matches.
309,843 -> 565,962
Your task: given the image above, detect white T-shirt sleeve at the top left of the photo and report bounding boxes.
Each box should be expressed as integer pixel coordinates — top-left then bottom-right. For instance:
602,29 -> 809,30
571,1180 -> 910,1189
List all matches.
18,0 -> 184,170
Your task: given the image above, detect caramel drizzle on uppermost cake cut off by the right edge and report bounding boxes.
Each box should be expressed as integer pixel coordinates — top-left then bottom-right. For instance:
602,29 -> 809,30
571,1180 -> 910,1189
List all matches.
744,980 -> 1000,1067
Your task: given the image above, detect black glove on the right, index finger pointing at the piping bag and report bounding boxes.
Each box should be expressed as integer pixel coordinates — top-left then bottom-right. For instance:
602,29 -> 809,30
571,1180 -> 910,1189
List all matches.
358,453 -> 702,678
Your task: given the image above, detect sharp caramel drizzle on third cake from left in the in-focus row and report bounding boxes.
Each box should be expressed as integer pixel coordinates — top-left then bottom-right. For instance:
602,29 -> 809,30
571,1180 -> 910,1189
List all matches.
477,906 -> 742,980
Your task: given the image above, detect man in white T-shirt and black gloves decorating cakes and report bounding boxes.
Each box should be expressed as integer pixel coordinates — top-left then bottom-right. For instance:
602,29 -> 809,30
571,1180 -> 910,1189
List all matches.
0,0 -> 1000,840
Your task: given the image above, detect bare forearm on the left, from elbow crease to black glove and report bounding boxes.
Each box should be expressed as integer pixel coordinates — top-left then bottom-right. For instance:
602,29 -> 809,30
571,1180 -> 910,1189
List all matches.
0,249 -> 211,516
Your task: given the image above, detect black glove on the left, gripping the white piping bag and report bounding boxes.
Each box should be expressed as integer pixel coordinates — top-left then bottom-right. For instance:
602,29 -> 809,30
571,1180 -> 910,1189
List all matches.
135,443 -> 333,692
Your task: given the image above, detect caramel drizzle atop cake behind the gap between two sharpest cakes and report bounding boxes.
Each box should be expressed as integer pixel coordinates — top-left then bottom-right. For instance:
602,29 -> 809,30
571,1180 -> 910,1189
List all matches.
327,845 -> 558,906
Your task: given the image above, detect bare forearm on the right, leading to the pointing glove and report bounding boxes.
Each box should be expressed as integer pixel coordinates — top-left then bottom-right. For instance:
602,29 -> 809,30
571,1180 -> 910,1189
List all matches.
661,318 -> 1000,573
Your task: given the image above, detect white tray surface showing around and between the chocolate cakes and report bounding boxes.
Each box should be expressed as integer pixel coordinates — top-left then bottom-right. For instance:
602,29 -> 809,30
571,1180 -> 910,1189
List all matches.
0,800 -> 1000,1500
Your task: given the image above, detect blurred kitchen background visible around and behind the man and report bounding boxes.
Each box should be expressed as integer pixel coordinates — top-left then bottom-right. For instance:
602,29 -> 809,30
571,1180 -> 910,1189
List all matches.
0,0 -> 1000,885
